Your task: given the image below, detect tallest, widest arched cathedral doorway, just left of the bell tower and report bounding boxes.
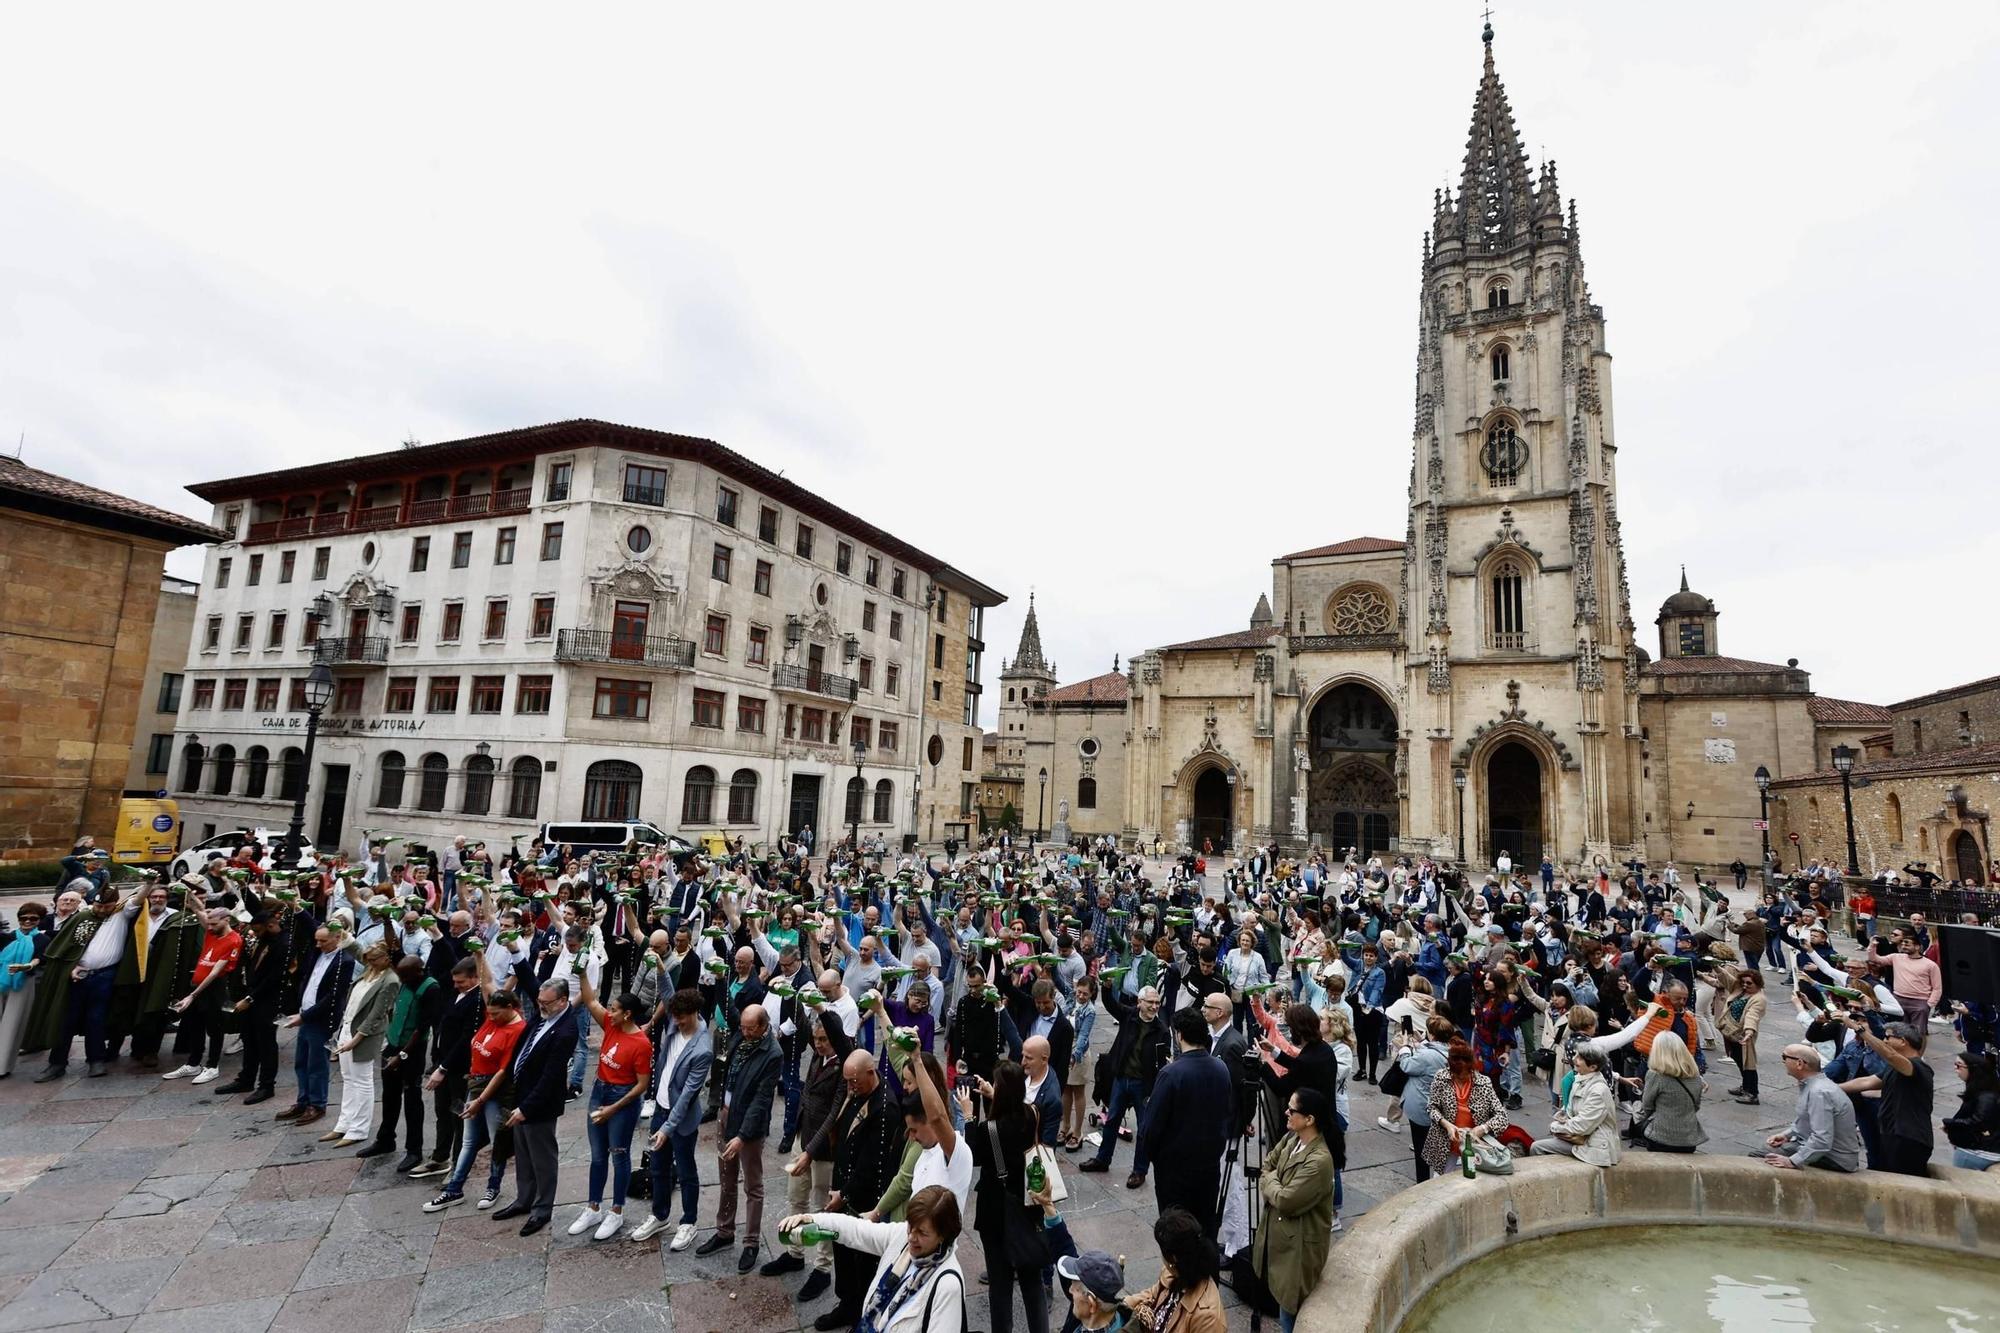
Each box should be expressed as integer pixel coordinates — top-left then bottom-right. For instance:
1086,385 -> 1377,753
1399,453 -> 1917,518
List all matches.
1306,681 -> 1400,857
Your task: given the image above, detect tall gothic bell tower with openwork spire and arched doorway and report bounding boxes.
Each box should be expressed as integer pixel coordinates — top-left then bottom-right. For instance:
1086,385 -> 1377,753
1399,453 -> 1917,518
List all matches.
1402,24 -> 1640,865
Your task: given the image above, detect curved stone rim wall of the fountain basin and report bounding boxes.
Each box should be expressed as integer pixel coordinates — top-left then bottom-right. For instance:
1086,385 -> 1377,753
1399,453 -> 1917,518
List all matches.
1298,1153 -> 2000,1333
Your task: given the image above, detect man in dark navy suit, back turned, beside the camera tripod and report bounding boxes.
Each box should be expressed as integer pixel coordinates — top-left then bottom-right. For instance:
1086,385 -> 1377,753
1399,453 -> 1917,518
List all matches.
1138,1005 -> 1234,1239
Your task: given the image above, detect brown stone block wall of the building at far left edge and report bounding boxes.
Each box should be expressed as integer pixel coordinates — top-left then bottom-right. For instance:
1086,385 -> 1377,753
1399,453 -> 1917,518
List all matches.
0,510 -> 166,855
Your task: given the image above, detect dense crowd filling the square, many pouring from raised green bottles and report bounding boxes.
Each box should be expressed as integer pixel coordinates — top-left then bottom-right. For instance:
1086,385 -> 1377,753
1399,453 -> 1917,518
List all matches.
0,833 -> 2000,1333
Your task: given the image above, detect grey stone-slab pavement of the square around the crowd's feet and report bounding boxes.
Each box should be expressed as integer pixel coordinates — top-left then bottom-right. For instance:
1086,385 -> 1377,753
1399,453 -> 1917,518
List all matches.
0,868 -> 1958,1333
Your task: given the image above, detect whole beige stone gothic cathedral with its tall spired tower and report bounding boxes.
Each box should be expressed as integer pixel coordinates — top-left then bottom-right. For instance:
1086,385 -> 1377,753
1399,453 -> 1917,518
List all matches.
982,26 -> 1888,869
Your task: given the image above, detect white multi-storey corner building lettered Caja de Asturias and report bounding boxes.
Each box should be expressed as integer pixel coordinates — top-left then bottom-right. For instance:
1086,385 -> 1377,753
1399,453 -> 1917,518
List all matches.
172,420 -> 1002,847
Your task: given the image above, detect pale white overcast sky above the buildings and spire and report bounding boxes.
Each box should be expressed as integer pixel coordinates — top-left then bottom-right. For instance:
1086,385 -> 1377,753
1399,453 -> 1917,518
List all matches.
0,2 -> 2000,723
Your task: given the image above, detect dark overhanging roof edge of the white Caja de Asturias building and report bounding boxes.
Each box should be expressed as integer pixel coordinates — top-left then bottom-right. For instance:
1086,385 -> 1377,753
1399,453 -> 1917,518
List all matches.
188,416 -> 1006,606
